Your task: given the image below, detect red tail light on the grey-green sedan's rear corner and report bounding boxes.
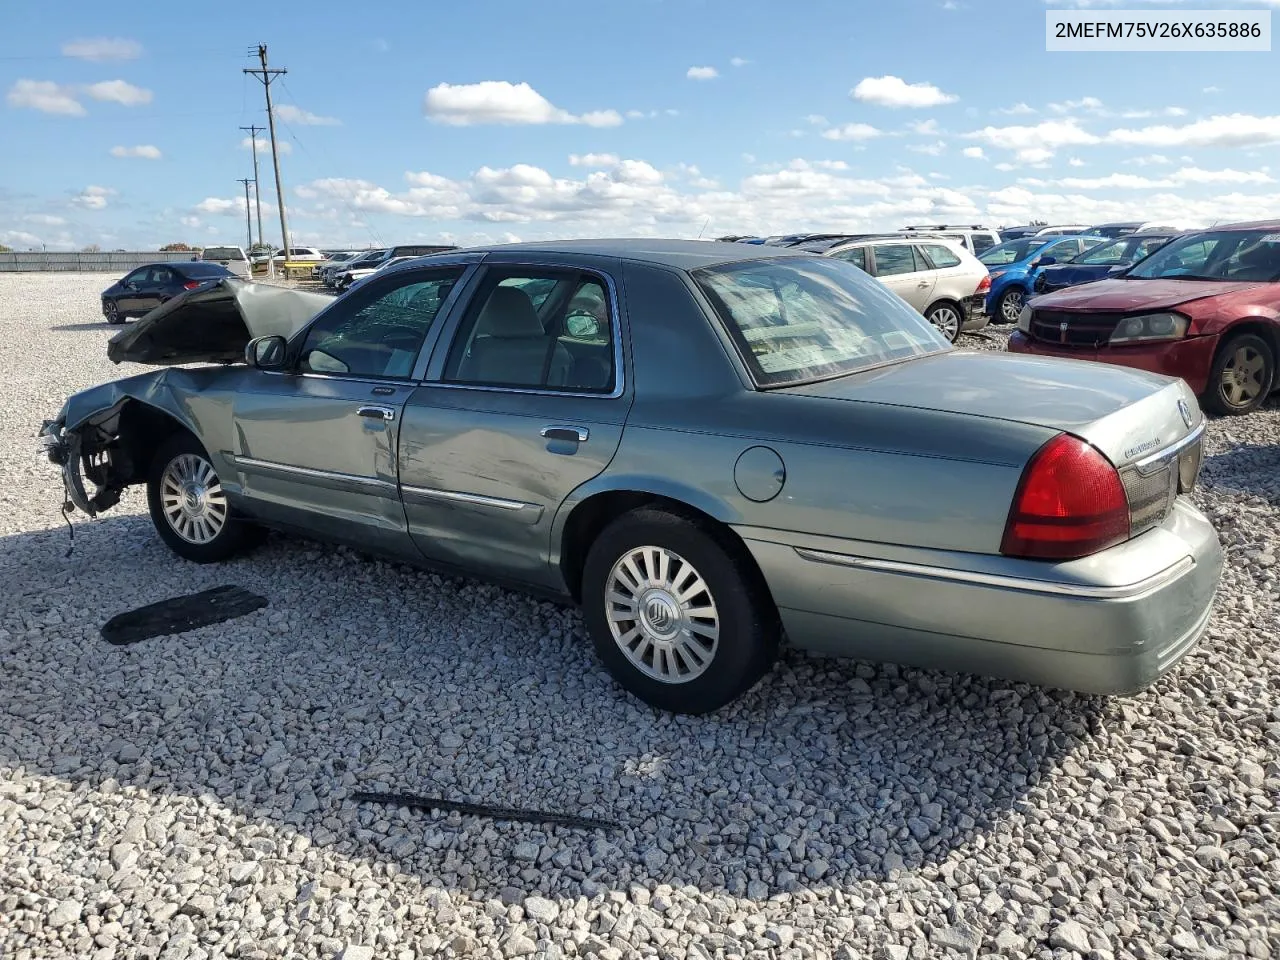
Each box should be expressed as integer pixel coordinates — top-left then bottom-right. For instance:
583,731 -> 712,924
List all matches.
1000,434 -> 1129,559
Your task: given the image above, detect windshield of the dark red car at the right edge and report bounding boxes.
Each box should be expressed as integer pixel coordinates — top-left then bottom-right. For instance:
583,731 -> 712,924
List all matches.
1125,229 -> 1280,283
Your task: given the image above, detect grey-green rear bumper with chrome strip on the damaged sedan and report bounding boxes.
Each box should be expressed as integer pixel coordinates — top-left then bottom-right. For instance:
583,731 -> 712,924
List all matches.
744,502 -> 1222,694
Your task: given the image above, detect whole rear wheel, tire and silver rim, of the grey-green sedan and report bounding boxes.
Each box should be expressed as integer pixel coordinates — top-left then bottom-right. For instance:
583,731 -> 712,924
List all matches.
582,508 -> 781,714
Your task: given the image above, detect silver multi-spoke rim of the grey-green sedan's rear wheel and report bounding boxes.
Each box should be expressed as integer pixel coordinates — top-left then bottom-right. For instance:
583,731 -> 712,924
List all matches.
604,547 -> 719,684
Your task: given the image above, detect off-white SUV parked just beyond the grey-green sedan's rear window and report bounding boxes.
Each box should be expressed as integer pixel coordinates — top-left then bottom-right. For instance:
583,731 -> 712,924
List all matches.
826,236 -> 991,343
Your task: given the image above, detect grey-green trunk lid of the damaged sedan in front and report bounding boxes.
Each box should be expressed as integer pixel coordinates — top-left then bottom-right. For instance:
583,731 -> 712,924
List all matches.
782,351 -> 1203,467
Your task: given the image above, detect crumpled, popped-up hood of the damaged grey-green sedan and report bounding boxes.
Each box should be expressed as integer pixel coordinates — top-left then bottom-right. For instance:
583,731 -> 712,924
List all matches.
106,276 -> 333,366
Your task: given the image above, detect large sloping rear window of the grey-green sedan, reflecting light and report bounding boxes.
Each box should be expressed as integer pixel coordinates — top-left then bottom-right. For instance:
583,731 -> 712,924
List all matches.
694,257 -> 951,387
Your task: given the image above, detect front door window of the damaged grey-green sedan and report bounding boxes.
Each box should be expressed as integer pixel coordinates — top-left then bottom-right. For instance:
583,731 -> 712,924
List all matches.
300,270 -> 462,379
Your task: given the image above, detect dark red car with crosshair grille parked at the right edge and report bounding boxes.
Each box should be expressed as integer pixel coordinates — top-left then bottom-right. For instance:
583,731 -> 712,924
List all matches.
1009,220 -> 1280,413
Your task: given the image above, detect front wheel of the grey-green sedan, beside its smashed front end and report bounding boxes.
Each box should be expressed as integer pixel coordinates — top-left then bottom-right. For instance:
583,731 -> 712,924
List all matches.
147,431 -> 259,563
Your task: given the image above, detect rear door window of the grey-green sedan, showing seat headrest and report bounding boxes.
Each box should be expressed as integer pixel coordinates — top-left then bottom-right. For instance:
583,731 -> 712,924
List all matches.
444,270 -> 617,393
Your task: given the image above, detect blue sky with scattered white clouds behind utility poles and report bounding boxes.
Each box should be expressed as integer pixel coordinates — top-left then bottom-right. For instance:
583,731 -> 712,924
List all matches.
0,0 -> 1280,250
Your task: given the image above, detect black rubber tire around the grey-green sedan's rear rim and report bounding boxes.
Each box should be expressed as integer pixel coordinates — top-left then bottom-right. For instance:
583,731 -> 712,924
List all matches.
582,507 -> 781,714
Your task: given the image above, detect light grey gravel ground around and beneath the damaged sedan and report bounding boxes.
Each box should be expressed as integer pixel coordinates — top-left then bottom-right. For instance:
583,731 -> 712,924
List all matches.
0,274 -> 1280,960
